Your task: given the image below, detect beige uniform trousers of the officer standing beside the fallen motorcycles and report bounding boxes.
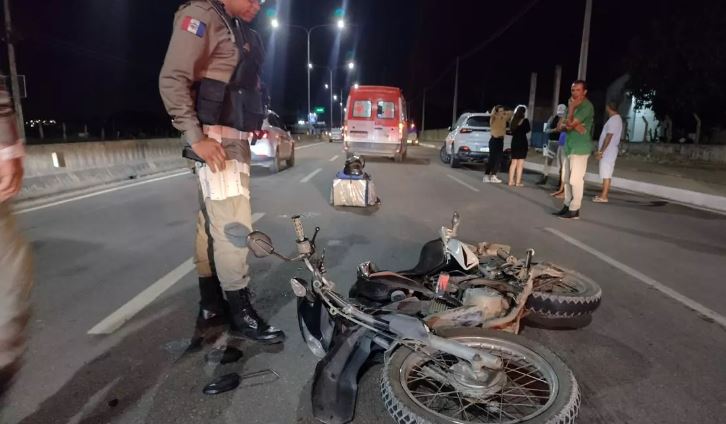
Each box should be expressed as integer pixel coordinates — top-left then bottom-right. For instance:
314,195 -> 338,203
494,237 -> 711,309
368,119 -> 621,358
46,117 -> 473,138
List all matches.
194,127 -> 252,291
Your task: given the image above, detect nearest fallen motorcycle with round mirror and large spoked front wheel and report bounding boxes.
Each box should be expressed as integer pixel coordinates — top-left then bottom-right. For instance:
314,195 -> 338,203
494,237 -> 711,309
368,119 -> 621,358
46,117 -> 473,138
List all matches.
247,217 -> 580,424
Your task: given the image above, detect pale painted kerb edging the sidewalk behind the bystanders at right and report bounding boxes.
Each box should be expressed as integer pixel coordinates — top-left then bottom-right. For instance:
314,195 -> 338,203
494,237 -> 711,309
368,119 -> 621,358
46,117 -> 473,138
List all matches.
524,162 -> 726,213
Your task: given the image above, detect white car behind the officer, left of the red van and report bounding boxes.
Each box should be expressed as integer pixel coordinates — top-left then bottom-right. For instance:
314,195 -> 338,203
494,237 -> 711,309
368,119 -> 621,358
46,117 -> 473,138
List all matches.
250,111 -> 295,173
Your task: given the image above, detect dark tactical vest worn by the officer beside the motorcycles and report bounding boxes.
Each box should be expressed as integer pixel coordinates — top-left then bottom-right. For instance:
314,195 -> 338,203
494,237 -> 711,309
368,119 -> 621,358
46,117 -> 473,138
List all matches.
196,0 -> 265,132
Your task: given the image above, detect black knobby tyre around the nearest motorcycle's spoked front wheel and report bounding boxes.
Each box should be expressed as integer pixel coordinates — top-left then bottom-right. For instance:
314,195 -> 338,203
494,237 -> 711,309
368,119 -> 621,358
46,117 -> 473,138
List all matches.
380,328 -> 581,424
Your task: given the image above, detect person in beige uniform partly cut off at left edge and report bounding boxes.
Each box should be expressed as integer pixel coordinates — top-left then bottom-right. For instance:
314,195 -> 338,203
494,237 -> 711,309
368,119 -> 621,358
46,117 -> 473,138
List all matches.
0,75 -> 32,395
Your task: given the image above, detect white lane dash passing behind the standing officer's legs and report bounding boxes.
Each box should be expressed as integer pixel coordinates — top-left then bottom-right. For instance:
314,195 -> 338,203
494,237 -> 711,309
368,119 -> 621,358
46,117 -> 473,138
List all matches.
88,212 -> 265,335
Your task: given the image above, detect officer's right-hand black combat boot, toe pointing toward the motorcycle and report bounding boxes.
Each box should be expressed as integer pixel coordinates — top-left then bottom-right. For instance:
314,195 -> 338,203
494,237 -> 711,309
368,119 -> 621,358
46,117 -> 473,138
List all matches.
225,288 -> 285,344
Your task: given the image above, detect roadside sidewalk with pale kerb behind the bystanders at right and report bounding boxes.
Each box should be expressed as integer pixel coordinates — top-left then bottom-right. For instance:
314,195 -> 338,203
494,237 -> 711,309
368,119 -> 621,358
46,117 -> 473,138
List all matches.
525,149 -> 726,212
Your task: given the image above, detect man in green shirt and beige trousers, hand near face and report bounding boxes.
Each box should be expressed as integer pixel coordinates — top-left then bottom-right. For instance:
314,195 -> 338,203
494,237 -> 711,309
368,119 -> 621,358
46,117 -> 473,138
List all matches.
554,80 -> 594,219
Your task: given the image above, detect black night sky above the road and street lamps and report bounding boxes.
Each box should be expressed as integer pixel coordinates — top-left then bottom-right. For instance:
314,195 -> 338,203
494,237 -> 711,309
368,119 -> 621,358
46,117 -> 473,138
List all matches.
3,0 -> 669,128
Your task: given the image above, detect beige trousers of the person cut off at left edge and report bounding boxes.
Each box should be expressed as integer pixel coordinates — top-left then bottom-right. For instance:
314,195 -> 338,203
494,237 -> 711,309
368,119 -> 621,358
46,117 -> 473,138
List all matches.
0,203 -> 33,390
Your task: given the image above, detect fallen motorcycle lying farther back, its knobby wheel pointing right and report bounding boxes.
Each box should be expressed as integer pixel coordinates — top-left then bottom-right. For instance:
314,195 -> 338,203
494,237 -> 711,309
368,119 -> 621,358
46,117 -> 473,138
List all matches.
349,213 -> 602,333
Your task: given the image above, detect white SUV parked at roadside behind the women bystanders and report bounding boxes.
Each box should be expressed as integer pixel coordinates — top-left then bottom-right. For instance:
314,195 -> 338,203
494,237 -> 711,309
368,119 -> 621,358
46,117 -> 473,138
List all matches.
440,112 -> 512,169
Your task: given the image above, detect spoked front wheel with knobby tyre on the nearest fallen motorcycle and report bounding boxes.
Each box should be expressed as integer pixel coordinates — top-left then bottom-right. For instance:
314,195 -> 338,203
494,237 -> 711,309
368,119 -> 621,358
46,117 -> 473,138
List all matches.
381,328 -> 580,424
